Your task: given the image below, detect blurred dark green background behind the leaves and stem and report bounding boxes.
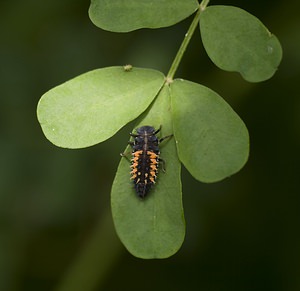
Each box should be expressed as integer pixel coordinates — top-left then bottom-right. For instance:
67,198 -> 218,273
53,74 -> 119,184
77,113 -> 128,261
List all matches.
0,0 -> 300,291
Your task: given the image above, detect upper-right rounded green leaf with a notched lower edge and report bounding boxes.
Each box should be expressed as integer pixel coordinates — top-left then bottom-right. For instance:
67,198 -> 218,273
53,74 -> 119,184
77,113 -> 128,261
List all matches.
200,6 -> 282,82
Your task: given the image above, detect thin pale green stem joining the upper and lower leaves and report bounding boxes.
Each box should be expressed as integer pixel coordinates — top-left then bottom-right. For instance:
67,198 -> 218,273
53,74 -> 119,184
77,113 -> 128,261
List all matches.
167,0 -> 209,82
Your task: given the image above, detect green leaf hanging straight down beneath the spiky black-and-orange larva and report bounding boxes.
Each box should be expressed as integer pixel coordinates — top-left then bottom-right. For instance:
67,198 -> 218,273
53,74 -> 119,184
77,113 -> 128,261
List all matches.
111,87 -> 185,259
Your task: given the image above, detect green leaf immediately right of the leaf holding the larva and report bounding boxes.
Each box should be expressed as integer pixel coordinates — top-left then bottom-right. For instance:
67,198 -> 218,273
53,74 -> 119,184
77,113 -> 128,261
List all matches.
171,80 -> 249,182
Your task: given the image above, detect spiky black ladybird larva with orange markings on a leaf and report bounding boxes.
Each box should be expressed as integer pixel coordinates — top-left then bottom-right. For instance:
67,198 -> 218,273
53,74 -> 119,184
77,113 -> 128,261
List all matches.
122,126 -> 172,198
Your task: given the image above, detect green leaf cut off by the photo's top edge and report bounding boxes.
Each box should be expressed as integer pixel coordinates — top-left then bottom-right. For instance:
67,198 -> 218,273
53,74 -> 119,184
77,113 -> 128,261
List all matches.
89,0 -> 199,32
